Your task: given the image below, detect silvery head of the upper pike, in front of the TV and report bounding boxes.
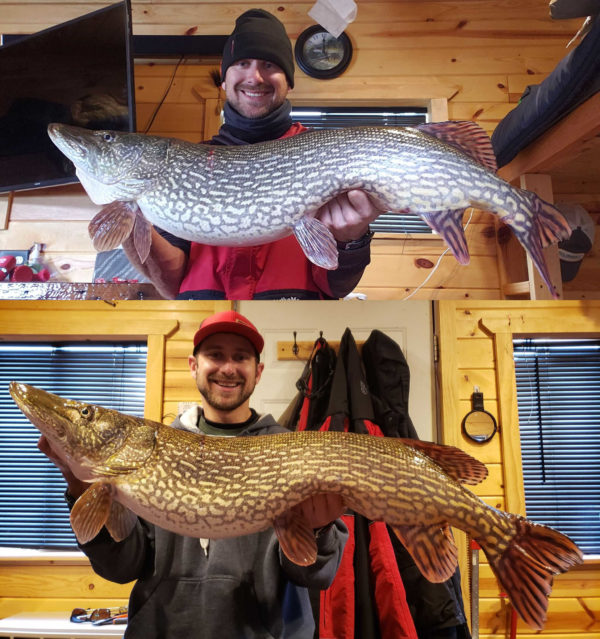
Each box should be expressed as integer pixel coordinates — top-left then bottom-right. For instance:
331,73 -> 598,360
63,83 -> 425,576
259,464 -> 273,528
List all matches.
48,124 -> 170,204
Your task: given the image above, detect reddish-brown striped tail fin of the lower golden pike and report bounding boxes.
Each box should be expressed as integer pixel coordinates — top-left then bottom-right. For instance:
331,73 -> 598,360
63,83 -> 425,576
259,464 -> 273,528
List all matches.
477,515 -> 583,630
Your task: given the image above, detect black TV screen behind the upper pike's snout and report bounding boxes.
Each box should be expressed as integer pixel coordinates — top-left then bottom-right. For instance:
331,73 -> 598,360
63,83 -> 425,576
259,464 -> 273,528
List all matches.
0,0 -> 135,192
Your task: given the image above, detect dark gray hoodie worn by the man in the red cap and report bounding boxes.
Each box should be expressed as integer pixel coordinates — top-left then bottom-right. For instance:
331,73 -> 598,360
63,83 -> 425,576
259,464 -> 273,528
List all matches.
76,410 -> 348,639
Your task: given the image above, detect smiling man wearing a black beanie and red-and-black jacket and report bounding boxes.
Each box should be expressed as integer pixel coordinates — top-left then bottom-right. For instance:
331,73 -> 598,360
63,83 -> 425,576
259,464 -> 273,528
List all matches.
123,9 -> 382,300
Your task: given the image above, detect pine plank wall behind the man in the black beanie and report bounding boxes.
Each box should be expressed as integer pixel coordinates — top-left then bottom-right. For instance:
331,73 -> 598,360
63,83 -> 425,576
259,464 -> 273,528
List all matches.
0,0 -> 579,299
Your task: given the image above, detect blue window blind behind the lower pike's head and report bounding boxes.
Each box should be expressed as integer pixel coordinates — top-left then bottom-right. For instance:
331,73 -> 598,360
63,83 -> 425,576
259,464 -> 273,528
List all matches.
0,342 -> 147,549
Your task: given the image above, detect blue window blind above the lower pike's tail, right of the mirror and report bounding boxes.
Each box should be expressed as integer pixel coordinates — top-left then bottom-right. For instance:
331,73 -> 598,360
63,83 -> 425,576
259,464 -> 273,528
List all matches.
513,339 -> 600,555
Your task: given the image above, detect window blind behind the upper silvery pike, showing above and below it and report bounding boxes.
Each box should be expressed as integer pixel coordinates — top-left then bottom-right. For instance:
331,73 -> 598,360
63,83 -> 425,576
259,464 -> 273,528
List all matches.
292,107 -> 432,235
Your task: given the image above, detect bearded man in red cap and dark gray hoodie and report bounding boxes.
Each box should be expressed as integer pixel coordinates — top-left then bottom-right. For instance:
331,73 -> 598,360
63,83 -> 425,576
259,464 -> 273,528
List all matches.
39,311 -> 348,639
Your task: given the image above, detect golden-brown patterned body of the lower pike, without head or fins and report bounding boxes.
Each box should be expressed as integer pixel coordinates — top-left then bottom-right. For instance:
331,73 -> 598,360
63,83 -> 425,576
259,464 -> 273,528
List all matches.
122,428 -> 506,538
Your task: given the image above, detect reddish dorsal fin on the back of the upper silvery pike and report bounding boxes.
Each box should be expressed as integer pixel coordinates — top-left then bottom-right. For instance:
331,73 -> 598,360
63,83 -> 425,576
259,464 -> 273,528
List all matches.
414,121 -> 498,173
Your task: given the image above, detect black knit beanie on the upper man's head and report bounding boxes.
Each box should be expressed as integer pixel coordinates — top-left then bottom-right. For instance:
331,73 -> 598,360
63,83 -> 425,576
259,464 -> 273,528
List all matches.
221,9 -> 294,88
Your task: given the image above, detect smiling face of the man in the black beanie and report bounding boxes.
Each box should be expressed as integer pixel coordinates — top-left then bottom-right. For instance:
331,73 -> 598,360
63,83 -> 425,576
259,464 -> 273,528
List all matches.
221,59 -> 289,119
